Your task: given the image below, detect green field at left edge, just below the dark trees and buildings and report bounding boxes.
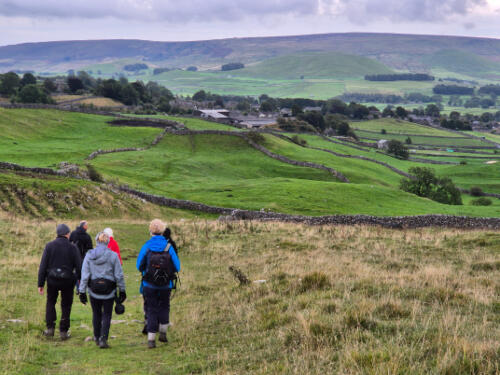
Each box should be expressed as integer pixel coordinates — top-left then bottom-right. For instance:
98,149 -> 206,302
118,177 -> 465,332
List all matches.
0,108 -> 160,167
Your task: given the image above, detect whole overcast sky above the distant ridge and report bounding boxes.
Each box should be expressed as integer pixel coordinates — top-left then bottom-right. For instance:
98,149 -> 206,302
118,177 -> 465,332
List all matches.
0,0 -> 500,45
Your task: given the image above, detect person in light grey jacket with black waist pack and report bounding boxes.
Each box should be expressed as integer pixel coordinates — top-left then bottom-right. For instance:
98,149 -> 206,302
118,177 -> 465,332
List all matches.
79,232 -> 127,349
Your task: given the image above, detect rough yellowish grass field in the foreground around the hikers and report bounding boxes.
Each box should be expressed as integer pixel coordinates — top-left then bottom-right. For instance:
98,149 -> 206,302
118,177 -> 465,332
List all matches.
0,211 -> 500,375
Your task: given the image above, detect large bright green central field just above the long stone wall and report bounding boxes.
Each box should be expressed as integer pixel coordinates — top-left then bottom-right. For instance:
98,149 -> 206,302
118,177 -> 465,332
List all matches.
93,131 -> 500,216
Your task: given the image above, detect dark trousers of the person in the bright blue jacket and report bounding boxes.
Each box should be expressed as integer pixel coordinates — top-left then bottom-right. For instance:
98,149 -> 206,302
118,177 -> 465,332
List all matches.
143,287 -> 171,333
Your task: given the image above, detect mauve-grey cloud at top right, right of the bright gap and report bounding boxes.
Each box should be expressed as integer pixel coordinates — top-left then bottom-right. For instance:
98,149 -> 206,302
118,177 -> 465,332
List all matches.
324,0 -> 487,23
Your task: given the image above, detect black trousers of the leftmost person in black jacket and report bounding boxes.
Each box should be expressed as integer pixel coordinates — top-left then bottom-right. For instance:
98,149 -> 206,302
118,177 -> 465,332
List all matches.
45,281 -> 75,332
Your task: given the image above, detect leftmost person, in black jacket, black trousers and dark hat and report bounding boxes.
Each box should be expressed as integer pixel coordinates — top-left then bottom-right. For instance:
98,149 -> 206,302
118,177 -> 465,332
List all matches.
38,224 -> 82,340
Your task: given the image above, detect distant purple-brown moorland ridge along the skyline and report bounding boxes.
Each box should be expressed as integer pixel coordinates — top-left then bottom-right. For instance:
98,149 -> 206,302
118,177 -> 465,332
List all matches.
0,33 -> 500,72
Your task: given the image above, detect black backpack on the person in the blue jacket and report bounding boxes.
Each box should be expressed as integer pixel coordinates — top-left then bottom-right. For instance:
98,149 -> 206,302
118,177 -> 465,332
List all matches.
144,245 -> 177,286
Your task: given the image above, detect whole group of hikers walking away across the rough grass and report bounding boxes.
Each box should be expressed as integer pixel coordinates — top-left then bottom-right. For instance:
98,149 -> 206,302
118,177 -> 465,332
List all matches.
38,219 -> 180,349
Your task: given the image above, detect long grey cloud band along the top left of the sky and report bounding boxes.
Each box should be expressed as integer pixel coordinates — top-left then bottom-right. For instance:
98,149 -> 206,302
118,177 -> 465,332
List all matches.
0,0 -> 318,23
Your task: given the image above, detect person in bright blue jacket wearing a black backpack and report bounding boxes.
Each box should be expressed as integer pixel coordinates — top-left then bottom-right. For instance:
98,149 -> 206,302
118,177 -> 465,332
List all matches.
136,219 -> 181,348
